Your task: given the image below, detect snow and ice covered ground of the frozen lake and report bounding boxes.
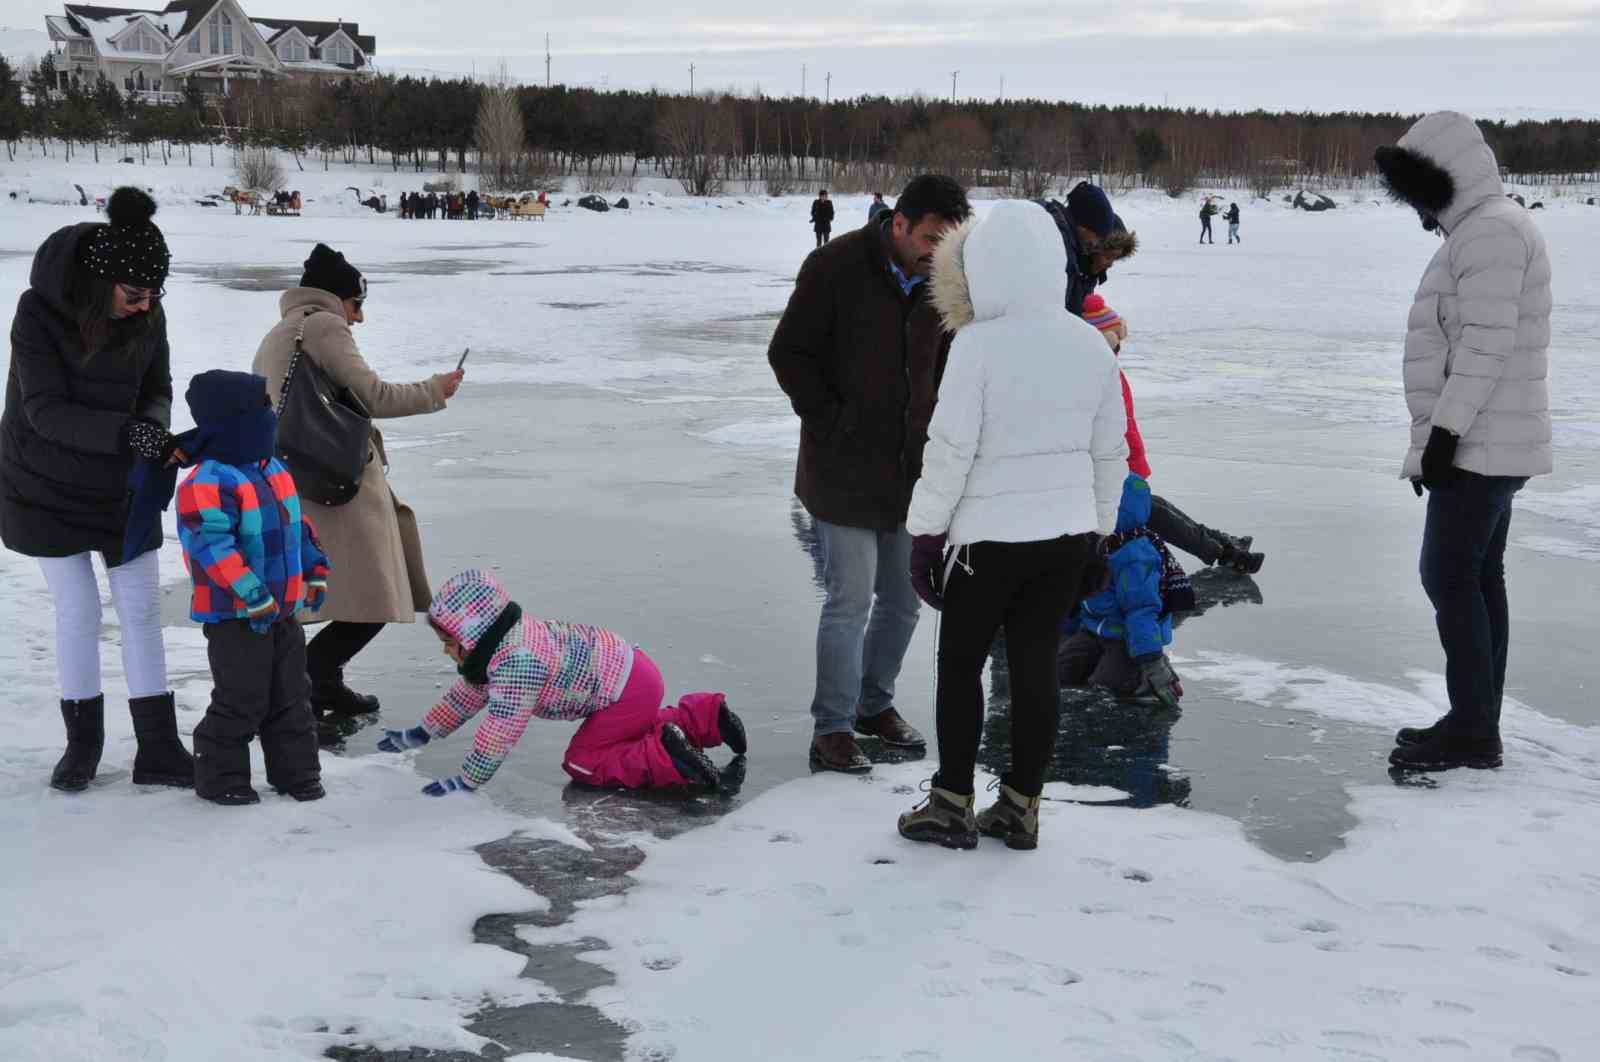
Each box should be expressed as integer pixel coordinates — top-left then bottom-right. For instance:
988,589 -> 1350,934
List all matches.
0,151 -> 1600,1062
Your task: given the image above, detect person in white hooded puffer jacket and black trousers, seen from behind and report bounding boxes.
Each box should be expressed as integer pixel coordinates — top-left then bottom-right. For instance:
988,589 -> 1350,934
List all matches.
899,202 -> 1128,849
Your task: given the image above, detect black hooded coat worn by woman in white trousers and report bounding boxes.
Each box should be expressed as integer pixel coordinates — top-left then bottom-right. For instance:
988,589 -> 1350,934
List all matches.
0,222 -> 173,565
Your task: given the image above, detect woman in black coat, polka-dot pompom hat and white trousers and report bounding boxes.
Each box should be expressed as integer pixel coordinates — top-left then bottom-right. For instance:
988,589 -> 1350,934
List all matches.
0,189 -> 194,792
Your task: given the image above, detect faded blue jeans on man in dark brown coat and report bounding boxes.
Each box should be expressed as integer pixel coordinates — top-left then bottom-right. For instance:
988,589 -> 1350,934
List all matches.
811,520 -> 922,737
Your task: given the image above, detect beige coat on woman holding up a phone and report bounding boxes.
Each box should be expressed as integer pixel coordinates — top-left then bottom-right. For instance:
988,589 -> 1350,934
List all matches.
253,288 -> 445,624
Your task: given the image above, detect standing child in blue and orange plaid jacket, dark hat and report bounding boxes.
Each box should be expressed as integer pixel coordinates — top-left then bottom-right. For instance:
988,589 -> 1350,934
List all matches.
178,371 -> 328,804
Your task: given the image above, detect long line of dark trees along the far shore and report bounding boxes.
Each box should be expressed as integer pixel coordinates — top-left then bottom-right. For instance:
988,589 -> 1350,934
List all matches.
0,56 -> 1600,195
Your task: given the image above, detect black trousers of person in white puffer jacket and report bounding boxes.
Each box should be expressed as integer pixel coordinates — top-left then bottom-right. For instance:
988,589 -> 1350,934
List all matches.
934,534 -> 1094,797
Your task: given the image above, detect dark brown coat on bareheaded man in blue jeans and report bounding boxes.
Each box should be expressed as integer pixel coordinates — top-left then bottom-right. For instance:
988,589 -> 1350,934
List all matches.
766,213 -> 950,531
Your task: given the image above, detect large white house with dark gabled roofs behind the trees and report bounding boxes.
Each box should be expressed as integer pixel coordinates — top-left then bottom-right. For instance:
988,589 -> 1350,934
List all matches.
45,0 -> 378,101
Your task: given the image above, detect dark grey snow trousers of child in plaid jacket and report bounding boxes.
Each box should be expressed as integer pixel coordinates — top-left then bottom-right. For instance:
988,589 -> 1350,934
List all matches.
194,619 -> 322,797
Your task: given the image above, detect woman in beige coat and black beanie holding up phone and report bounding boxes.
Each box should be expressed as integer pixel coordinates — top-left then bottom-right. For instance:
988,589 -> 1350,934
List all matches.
253,243 -> 462,715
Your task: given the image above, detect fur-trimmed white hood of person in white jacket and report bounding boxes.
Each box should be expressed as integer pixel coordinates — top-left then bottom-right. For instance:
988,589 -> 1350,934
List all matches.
930,200 -> 1067,333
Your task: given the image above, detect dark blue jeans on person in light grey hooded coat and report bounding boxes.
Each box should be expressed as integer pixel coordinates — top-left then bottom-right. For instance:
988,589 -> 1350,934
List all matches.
1421,470 -> 1528,737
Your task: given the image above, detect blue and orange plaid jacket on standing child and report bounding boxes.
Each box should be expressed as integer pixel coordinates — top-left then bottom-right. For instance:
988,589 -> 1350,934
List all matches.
178,457 -> 328,624
